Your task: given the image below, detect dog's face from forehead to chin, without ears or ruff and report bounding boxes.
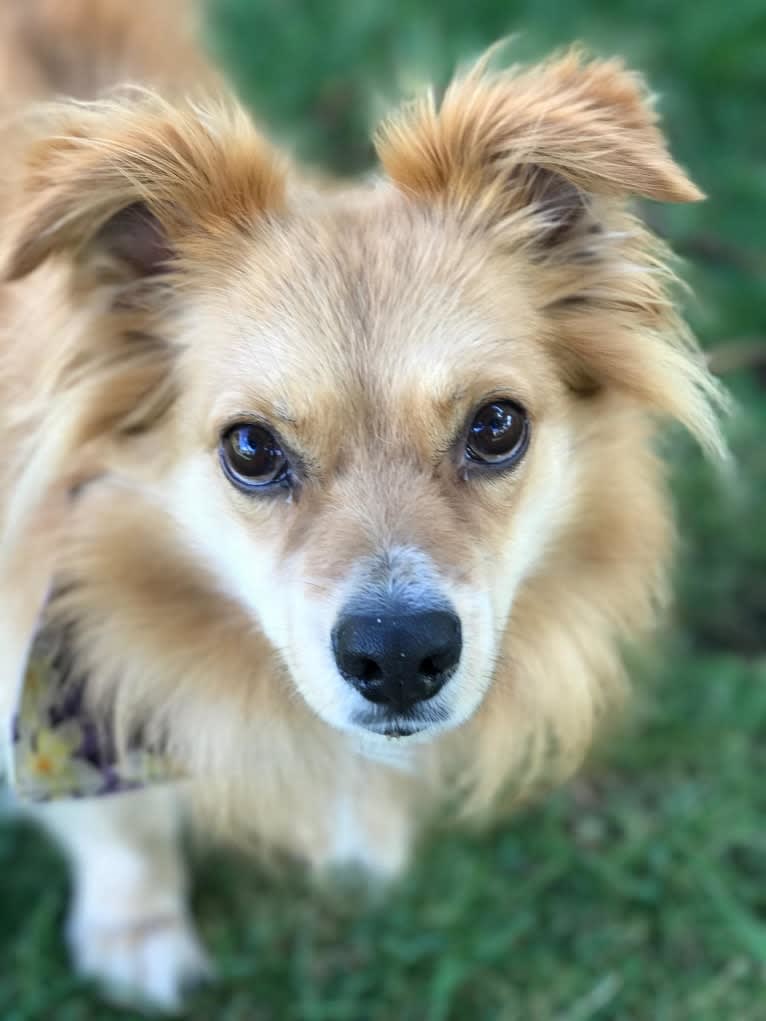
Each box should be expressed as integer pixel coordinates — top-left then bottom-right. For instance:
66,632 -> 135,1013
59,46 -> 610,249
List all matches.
162,205 -> 573,735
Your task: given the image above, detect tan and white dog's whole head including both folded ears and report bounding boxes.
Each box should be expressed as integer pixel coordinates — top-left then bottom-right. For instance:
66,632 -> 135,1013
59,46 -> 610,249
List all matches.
3,54 -> 718,800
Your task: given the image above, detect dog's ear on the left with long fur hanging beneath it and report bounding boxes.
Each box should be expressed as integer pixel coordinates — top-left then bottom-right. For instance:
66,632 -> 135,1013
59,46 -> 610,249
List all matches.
0,92 -> 285,449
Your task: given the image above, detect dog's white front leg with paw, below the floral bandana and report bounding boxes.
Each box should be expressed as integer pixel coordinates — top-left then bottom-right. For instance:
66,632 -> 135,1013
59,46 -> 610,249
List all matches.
36,788 -> 209,1010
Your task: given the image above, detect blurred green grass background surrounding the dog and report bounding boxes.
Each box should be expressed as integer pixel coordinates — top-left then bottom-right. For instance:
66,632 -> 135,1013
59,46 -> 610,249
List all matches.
0,0 -> 766,1021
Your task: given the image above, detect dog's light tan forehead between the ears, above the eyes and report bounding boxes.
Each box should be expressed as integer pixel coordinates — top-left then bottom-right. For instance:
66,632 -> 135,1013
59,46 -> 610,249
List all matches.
184,195 -> 547,426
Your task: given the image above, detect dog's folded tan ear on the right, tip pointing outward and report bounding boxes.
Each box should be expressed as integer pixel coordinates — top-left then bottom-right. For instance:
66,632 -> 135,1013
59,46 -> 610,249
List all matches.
376,50 -> 703,240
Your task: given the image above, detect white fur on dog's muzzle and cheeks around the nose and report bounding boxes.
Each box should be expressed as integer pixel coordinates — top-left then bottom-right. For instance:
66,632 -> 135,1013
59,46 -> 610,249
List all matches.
165,418 -> 572,747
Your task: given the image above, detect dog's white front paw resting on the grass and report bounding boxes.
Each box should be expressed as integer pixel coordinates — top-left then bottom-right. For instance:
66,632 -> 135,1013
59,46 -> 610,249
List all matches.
68,915 -> 212,1013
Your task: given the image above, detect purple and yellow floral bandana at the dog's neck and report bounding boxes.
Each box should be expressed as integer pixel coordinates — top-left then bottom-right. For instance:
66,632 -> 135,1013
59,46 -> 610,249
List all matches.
6,629 -> 181,801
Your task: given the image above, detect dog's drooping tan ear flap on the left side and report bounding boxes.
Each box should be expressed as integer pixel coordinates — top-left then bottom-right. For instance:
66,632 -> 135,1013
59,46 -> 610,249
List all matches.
1,96 -> 284,281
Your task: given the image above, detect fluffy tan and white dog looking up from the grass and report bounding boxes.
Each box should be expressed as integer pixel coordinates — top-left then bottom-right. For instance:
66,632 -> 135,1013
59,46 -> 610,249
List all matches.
0,0 -> 724,1007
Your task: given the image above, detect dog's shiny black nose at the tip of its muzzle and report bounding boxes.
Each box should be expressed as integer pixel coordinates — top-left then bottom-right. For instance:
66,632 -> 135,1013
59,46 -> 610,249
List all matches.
333,610 -> 463,713
